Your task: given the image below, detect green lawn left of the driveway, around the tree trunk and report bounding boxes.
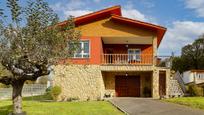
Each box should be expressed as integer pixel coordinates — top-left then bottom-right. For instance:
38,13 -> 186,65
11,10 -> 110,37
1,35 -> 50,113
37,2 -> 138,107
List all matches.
0,96 -> 123,115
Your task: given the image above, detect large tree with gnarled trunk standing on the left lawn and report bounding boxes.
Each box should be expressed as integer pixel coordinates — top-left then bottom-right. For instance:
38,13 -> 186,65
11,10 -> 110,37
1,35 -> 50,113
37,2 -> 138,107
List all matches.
0,0 -> 80,114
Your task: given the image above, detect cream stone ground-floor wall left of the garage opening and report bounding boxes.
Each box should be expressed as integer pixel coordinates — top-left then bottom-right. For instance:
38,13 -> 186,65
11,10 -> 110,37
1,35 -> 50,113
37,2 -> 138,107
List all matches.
53,65 -> 104,101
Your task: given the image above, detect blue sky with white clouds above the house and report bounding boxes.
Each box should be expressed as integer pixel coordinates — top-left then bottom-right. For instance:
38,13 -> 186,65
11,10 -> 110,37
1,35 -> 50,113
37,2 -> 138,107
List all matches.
0,0 -> 204,55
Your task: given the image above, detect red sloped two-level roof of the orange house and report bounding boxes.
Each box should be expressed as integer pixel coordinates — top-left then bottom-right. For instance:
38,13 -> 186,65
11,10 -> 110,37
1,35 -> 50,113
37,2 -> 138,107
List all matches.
58,6 -> 167,46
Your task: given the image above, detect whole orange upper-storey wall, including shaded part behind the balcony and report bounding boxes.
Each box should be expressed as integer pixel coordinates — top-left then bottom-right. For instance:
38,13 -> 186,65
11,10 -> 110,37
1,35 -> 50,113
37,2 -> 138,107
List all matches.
67,36 -> 153,64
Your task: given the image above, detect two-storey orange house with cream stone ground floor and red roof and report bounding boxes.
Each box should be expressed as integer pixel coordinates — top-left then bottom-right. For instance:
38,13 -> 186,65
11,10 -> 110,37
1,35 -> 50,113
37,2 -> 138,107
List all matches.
53,6 -> 170,100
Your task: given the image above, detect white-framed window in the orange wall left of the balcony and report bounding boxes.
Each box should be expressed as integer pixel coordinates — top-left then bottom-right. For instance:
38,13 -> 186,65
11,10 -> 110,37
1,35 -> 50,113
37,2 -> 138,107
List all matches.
74,40 -> 90,58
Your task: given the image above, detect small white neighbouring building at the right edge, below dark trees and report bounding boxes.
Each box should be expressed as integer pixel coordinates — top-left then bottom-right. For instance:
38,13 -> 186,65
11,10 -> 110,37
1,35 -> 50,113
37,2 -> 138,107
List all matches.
183,70 -> 204,85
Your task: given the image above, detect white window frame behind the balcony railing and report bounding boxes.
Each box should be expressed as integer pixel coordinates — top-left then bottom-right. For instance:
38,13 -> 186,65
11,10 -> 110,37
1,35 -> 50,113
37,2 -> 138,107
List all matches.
128,48 -> 142,62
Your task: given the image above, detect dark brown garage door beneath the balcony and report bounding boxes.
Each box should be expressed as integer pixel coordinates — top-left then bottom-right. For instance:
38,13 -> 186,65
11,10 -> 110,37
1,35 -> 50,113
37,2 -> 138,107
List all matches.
115,76 -> 140,97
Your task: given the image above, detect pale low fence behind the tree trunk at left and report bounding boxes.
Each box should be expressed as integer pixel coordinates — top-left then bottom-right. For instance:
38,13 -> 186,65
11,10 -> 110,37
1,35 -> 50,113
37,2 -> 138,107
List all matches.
0,84 -> 47,100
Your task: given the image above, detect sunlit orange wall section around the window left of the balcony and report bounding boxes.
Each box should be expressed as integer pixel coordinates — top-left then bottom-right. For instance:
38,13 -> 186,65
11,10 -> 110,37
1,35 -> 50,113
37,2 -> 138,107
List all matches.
71,36 -> 103,64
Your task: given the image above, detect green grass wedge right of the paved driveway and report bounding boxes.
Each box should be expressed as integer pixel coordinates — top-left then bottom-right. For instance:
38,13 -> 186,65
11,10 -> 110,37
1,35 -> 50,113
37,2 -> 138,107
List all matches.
165,97 -> 204,109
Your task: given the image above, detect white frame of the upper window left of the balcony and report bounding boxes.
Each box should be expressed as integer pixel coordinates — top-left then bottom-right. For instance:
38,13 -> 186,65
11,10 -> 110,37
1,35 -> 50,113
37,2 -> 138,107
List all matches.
73,40 -> 91,58
